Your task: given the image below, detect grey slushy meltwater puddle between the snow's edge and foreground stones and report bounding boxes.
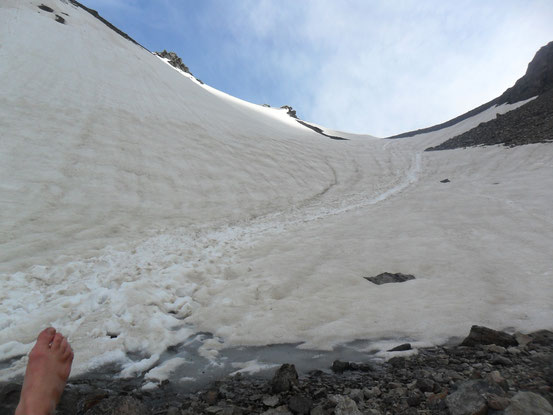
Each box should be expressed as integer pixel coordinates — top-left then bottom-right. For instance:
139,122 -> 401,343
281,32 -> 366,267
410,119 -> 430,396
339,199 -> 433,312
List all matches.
73,333 -> 422,393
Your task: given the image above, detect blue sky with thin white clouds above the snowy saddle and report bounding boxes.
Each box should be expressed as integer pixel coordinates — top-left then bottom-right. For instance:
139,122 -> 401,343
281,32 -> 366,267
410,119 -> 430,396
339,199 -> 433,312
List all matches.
83,0 -> 553,137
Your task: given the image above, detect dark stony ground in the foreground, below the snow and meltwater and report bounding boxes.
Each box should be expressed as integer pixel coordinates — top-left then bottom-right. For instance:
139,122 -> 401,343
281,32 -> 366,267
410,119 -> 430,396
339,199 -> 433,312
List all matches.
0,326 -> 553,415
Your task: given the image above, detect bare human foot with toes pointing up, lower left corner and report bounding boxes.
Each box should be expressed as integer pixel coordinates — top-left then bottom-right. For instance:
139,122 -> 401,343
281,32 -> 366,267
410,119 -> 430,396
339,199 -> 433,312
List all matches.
15,327 -> 73,415
